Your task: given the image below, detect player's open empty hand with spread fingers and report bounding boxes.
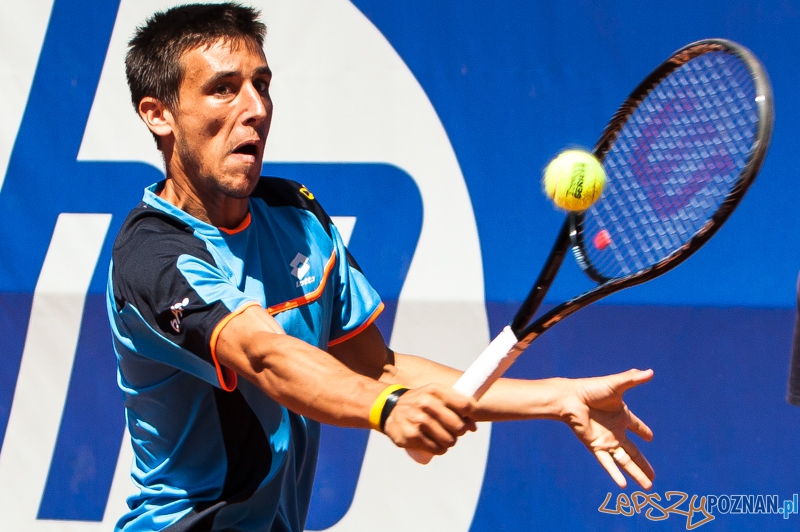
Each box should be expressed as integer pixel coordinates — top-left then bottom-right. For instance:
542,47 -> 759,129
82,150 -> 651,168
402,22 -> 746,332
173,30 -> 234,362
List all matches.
562,369 -> 655,490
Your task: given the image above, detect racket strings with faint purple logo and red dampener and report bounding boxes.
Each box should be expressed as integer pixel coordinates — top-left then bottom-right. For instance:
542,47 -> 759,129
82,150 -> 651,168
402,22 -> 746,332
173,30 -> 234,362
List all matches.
582,52 -> 759,279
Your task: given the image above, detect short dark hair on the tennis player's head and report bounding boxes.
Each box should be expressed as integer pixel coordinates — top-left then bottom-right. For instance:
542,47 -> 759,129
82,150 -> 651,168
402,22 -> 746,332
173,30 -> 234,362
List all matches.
125,2 -> 267,113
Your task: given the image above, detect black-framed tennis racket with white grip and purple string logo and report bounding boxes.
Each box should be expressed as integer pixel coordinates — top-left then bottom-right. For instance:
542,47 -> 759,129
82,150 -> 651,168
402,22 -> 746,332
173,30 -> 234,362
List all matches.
409,39 -> 773,463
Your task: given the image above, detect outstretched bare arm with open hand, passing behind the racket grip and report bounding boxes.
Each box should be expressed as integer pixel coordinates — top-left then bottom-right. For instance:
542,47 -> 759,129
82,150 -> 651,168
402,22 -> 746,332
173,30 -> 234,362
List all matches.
331,326 -> 655,489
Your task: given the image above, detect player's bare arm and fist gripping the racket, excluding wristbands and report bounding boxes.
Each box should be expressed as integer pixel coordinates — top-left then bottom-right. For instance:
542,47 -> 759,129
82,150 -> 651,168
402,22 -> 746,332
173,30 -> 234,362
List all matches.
215,306 -> 475,454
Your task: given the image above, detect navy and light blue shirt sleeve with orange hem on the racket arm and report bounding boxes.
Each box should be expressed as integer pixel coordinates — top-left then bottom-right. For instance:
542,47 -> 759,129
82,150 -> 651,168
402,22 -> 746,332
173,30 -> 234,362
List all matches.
111,210 -> 258,390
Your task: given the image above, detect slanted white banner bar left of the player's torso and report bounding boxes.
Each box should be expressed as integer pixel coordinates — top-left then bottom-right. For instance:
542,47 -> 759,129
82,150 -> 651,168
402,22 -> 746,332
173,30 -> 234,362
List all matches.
0,213 -> 137,532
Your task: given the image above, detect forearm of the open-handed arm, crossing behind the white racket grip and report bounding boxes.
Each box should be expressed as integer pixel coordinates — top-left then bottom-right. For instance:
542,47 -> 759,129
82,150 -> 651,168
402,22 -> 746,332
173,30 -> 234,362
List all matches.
388,353 -> 571,421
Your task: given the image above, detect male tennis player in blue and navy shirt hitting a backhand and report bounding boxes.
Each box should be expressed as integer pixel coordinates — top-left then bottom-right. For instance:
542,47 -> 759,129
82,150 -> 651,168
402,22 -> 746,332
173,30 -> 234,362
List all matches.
108,4 -> 653,532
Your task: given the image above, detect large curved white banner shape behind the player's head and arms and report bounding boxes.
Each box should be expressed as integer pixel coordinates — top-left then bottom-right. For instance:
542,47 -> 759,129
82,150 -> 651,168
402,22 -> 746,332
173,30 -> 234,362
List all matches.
78,0 -> 490,532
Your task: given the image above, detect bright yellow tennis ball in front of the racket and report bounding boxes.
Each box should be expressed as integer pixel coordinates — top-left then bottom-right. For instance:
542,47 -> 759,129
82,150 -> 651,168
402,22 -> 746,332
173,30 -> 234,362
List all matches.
544,150 -> 606,211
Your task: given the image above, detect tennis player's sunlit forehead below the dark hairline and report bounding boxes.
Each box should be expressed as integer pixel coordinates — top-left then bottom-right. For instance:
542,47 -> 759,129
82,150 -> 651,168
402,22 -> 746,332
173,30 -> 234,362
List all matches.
181,38 -> 267,81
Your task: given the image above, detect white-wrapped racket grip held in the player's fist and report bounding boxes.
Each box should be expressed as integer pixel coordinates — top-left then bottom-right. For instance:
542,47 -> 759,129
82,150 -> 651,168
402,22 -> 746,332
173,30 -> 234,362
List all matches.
407,326 -> 523,464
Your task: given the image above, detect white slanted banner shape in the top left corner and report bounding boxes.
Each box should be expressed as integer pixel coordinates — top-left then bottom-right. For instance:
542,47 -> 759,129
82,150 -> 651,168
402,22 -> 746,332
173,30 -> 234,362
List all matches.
0,0 -> 53,190
